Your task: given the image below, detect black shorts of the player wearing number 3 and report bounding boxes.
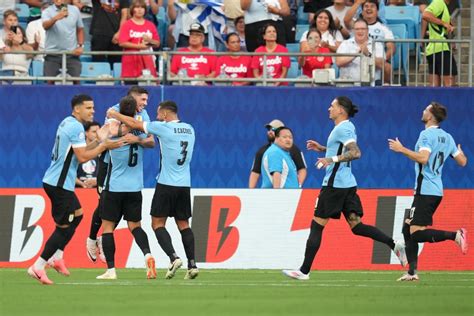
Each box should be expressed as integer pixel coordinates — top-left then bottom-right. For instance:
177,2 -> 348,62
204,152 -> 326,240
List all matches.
150,183 -> 191,220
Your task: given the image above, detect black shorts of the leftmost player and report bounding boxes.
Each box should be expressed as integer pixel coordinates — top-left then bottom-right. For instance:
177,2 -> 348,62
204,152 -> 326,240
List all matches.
43,183 -> 81,225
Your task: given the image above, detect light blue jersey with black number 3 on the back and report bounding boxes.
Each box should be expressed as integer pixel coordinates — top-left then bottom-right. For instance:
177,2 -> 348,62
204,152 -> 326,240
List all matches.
143,120 -> 195,187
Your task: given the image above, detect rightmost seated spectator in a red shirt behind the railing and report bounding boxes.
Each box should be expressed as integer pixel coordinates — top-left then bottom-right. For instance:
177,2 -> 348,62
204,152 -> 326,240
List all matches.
298,28 -> 332,78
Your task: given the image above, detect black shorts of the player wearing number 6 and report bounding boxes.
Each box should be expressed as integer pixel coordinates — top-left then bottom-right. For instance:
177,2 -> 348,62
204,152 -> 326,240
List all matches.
99,191 -> 142,223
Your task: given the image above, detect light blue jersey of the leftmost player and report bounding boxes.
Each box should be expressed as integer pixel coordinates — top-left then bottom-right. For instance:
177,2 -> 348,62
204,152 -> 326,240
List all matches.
43,116 -> 86,191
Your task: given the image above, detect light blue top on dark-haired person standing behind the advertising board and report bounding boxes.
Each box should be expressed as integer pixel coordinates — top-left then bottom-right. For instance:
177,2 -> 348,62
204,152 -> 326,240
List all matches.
261,144 -> 299,189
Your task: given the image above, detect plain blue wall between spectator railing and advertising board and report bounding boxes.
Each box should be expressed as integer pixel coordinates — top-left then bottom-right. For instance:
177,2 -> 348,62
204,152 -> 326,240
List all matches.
0,86 -> 474,189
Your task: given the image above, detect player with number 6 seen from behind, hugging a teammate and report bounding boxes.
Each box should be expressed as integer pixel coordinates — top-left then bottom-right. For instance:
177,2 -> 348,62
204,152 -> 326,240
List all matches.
97,96 -> 156,280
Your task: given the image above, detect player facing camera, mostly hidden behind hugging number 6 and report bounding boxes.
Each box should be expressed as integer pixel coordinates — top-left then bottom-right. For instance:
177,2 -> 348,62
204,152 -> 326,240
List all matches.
86,86 -> 155,263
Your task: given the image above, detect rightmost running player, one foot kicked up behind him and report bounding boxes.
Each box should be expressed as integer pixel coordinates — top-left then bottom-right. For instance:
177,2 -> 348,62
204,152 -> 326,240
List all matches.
388,102 -> 468,281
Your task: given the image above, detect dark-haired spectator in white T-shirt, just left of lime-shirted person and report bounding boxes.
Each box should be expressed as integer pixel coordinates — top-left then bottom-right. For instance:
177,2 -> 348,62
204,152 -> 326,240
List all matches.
345,0 -> 395,83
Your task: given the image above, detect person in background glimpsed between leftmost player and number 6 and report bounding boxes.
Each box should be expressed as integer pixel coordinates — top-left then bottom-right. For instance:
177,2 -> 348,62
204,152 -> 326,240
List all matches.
76,121 -> 100,188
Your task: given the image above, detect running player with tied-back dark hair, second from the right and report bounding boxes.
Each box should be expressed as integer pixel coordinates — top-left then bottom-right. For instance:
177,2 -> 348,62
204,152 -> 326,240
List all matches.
283,96 -> 406,280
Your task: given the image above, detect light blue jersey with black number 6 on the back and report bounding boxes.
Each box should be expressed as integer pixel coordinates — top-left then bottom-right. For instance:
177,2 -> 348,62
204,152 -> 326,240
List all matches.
105,144 -> 143,192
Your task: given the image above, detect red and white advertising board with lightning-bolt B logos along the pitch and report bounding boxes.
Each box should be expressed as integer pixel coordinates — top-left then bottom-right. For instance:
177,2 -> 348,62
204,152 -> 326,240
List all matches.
0,189 -> 474,270
